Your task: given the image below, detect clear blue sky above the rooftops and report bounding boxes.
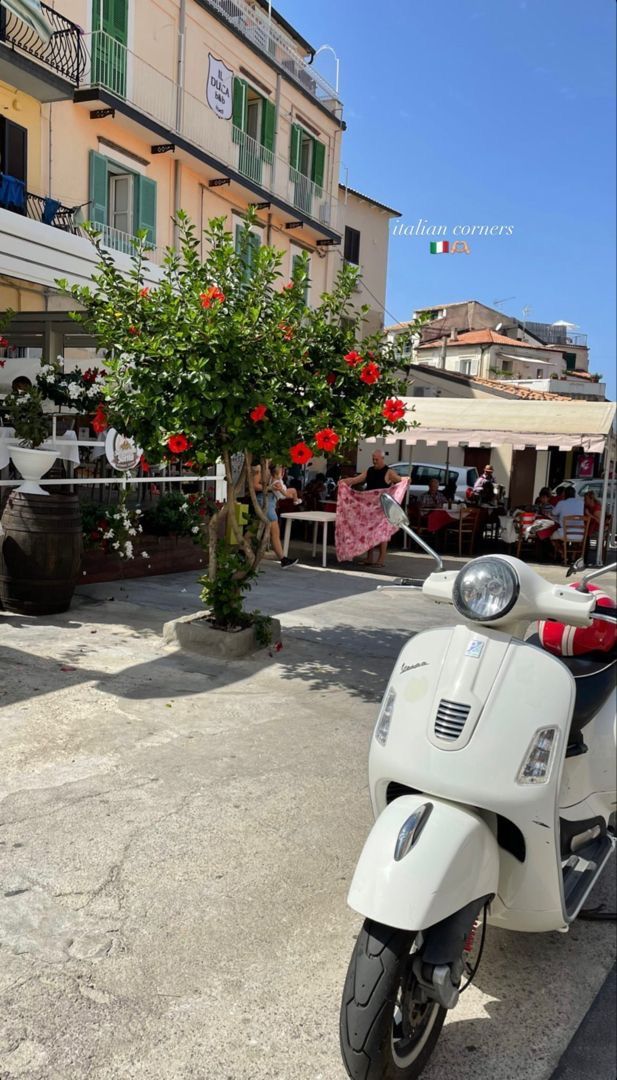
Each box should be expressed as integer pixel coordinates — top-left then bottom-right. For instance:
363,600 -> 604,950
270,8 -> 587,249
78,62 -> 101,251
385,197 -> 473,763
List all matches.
283,0 -> 616,397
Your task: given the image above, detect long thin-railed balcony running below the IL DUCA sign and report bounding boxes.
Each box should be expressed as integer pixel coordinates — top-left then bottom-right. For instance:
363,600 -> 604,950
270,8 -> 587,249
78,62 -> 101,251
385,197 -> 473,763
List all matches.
78,30 -> 339,233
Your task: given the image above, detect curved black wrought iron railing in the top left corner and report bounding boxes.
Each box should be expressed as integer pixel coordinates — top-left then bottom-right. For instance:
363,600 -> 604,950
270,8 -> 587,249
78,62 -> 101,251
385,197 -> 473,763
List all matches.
0,3 -> 86,86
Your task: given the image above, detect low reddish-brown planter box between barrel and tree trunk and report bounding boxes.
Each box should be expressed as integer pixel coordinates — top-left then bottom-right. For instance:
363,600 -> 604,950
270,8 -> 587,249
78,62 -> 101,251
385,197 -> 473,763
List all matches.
78,534 -> 207,584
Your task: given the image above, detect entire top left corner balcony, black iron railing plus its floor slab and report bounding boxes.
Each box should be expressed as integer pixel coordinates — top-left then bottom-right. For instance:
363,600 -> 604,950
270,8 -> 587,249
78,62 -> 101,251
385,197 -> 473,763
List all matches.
0,3 -> 86,102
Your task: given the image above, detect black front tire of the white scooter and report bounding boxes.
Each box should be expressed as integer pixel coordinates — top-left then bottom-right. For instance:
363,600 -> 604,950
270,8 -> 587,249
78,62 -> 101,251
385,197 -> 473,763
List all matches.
340,919 -> 447,1080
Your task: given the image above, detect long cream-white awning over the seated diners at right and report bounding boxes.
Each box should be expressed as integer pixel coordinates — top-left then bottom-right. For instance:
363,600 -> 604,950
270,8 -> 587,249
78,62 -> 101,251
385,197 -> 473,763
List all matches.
370,397 -> 615,454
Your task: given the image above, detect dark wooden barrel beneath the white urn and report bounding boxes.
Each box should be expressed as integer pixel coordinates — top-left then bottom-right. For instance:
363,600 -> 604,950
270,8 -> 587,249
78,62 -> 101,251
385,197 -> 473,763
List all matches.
0,491 -> 82,615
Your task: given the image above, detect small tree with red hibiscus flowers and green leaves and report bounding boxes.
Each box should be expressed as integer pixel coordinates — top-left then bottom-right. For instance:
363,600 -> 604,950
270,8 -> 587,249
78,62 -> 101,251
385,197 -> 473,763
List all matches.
61,213 -> 417,623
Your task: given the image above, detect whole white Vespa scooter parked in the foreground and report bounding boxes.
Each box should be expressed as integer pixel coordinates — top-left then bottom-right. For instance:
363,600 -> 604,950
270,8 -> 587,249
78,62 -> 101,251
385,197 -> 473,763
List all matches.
340,495 -> 616,1080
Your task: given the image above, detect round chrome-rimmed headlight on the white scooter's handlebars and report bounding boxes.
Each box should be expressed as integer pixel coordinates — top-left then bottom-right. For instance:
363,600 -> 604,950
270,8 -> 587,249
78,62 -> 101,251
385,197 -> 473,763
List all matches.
452,556 -> 521,622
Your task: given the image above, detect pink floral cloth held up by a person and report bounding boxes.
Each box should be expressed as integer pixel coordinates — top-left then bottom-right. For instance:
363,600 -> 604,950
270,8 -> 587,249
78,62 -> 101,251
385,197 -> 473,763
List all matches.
336,480 -> 407,563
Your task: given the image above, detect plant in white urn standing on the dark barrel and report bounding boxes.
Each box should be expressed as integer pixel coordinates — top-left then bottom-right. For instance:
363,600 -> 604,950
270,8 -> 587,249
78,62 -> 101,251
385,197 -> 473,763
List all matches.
3,387 -> 57,495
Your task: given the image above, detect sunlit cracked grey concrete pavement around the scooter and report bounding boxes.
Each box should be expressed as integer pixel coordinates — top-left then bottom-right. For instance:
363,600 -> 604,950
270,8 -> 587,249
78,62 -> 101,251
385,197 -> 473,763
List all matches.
0,555 -> 615,1080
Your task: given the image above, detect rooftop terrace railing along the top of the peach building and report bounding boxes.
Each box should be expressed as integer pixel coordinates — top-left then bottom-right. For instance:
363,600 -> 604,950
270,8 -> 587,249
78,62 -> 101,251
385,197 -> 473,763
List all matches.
199,0 -> 343,118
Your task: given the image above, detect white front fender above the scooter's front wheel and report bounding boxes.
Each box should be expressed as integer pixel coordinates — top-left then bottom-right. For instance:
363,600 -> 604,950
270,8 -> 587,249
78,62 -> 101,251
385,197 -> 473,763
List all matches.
347,795 -> 499,931
